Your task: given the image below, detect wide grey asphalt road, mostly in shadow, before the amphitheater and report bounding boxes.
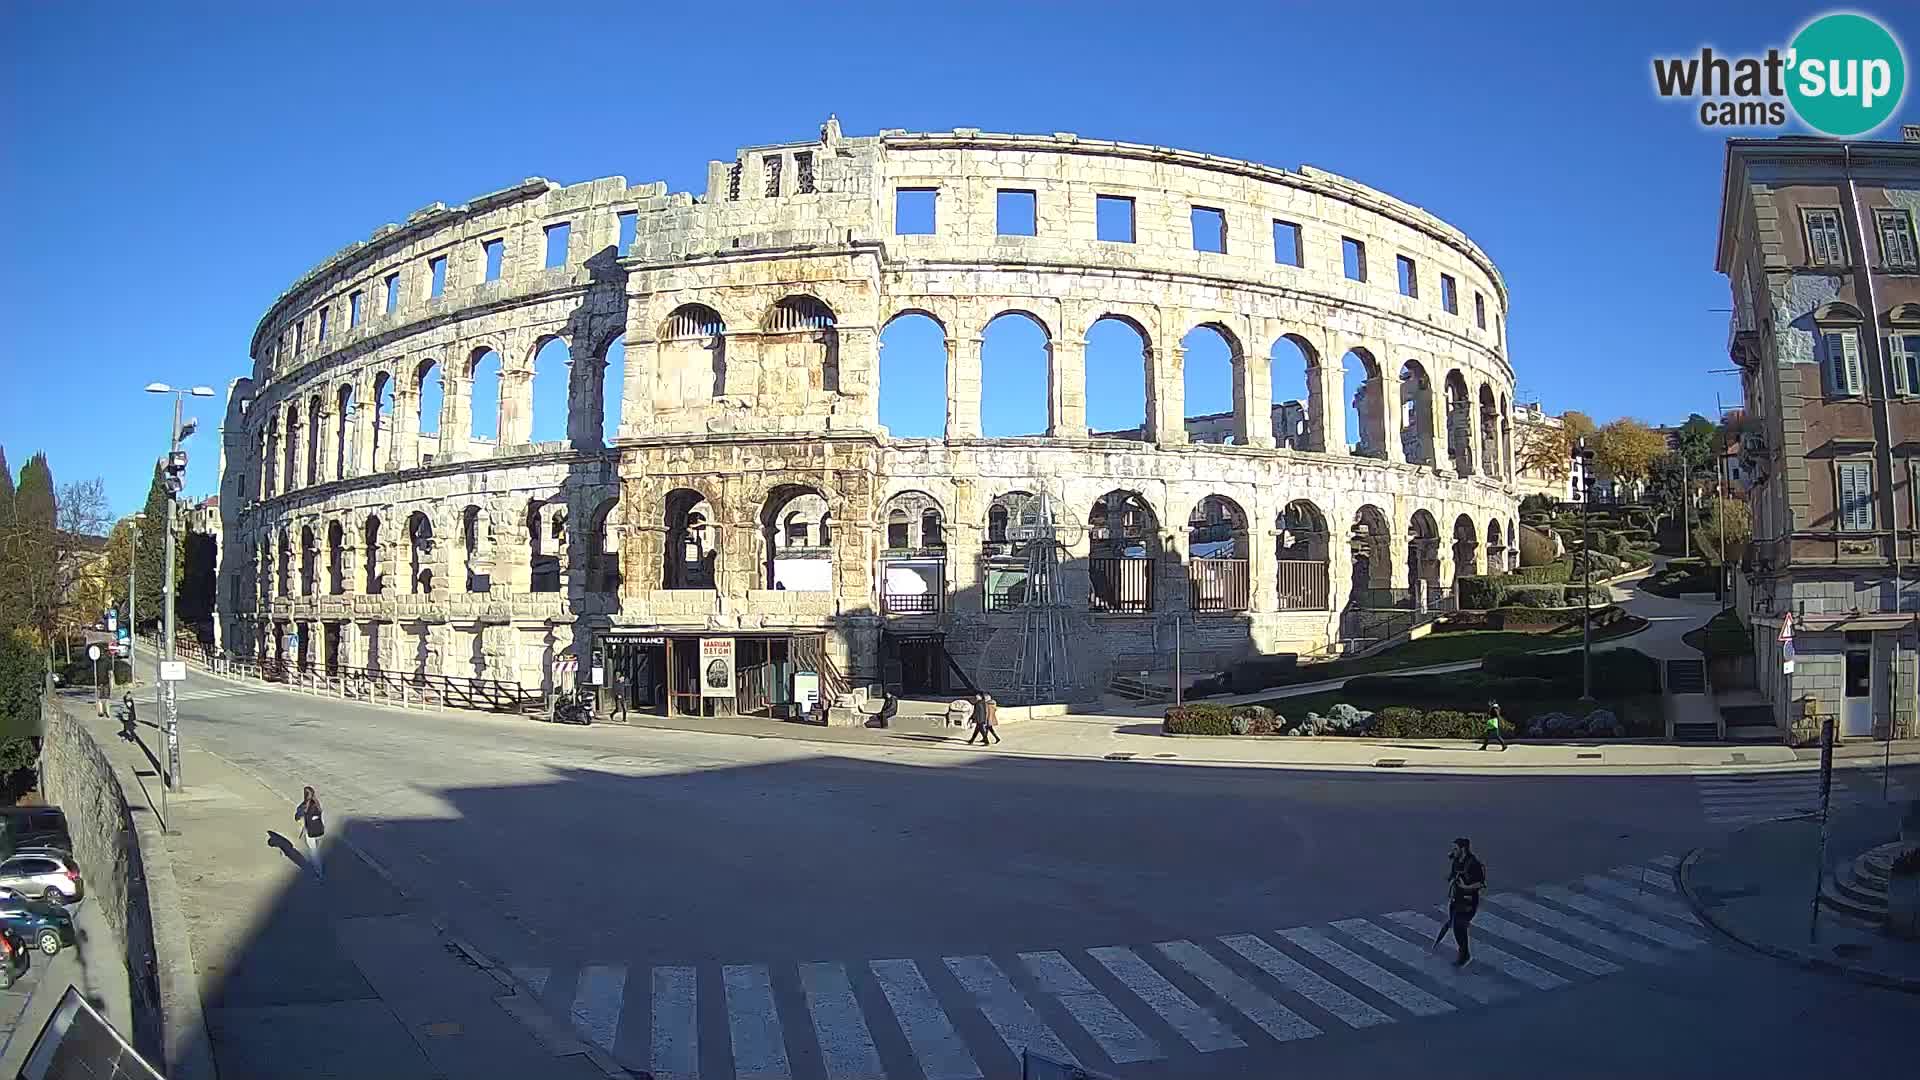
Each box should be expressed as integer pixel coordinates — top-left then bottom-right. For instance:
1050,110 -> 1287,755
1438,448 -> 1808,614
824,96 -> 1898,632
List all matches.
153,675 -> 1920,1078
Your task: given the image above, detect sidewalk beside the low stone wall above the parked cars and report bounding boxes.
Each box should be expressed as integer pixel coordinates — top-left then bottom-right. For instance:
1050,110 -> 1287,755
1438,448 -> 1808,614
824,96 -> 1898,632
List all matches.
76,699 -> 607,1080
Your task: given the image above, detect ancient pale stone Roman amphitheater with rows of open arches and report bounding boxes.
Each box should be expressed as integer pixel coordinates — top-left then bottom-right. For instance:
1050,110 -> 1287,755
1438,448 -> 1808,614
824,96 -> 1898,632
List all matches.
219,119 -> 1517,717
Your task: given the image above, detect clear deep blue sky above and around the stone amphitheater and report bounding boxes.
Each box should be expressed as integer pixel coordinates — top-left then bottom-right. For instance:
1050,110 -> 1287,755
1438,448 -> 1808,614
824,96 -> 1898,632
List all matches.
0,0 -> 1920,513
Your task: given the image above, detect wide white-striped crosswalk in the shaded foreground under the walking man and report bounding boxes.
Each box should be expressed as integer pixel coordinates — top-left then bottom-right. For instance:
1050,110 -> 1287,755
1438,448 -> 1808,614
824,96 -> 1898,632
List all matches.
513,855 -> 1707,1080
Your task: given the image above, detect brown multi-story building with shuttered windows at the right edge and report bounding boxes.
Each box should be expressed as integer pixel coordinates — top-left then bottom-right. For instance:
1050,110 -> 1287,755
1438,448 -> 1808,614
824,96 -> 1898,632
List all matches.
1716,136 -> 1920,738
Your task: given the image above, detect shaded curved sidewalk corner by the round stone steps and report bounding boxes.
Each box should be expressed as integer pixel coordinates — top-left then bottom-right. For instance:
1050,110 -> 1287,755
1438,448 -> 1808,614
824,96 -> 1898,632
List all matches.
1680,805 -> 1920,994
